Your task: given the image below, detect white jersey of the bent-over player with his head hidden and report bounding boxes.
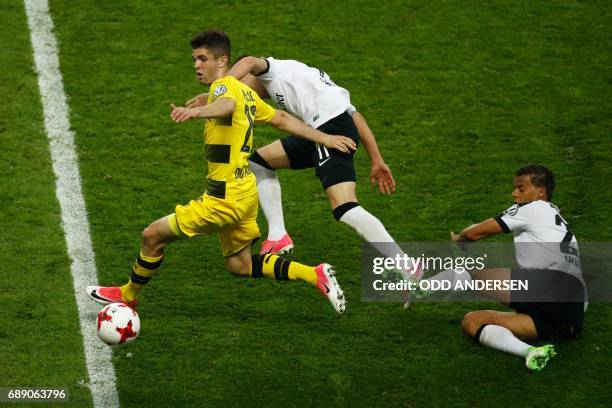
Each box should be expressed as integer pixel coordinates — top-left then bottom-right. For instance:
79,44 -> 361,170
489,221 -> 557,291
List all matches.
257,57 -> 355,128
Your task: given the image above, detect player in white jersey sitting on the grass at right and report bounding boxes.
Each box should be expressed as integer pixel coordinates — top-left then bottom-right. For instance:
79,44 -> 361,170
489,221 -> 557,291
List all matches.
432,165 -> 587,370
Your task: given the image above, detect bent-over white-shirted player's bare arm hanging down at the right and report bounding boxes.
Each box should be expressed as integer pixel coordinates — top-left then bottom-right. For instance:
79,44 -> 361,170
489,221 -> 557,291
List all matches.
353,112 -> 395,194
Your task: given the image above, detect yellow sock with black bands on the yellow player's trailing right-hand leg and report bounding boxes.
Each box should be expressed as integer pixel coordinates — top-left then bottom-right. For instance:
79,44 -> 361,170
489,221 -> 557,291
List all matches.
251,255 -> 317,285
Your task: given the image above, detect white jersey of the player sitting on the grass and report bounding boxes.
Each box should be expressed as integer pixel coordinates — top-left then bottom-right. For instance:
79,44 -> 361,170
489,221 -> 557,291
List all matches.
495,200 -> 584,282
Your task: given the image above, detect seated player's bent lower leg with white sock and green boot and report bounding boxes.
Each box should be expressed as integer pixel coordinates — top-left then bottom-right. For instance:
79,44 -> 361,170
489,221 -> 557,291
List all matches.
461,310 -> 556,371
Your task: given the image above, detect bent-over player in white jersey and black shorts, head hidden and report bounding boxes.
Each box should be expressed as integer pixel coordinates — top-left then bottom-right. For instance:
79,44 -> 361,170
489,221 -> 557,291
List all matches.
229,57 -> 400,253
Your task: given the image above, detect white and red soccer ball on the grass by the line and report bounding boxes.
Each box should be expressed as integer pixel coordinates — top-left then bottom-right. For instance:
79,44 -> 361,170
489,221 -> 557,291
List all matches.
98,303 -> 140,346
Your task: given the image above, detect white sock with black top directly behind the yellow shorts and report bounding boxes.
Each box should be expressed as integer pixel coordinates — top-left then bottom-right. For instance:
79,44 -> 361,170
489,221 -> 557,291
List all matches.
249,161 -> 287,241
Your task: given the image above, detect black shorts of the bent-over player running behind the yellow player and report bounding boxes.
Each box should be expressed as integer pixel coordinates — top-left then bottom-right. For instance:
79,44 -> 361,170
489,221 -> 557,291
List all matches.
281,112 -> 359,189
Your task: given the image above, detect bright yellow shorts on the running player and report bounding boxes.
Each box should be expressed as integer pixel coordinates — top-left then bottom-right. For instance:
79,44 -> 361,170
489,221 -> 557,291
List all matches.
176,193 -> 260,256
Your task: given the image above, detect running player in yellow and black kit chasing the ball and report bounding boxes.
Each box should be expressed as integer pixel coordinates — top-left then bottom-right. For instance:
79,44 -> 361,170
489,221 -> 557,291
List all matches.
87,30 -> 356,313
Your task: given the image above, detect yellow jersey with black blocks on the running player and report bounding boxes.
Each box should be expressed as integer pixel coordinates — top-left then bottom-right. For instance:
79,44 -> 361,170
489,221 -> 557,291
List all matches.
204,76 -> 276,199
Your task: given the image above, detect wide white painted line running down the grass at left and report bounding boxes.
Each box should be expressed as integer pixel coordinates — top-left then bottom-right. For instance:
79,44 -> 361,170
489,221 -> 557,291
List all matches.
24,0 -> 119,408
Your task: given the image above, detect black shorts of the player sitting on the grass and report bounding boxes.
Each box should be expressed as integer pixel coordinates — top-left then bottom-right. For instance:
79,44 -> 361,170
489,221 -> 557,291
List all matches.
509,269 -> 586,340
